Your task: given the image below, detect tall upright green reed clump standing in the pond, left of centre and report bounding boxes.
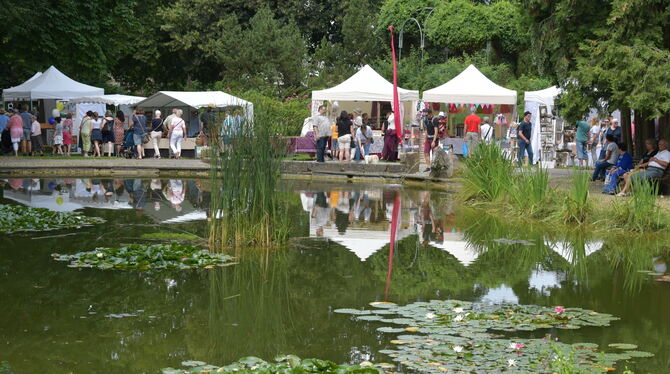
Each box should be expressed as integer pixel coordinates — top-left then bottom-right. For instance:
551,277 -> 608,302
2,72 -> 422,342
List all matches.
210,103 -> 289,250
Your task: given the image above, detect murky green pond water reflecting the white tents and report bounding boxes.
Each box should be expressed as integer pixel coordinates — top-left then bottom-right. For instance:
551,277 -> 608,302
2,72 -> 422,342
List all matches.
0,178 -> 670,374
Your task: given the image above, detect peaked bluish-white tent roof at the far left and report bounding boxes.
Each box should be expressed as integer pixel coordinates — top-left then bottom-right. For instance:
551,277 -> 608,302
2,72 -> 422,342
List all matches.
2,66 -> 105,100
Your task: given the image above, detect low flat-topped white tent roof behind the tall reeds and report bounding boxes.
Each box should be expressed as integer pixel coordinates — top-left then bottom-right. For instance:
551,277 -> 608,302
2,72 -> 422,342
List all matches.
137,91 -> 253,109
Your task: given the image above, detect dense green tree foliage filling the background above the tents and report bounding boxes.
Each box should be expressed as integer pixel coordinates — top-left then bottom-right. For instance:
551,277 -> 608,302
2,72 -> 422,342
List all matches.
0,0 -> 670,139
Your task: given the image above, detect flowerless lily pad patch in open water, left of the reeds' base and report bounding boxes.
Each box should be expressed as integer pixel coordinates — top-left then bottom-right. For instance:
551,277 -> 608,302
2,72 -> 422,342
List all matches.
51,242 -> 234,270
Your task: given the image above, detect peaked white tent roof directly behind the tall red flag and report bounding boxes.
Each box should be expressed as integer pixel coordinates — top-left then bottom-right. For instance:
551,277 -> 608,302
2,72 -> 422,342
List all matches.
312,65 -> 419,101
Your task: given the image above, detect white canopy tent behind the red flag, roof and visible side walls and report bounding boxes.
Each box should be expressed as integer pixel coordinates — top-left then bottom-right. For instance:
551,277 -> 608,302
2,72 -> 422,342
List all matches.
312,65 -> 419,125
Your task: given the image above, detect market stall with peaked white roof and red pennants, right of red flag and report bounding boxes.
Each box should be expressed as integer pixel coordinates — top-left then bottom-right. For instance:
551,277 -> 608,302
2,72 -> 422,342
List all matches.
423,65 -> 517,153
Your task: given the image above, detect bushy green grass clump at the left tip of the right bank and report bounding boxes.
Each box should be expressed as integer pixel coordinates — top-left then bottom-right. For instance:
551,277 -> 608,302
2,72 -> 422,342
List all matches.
462,143 -> 513,201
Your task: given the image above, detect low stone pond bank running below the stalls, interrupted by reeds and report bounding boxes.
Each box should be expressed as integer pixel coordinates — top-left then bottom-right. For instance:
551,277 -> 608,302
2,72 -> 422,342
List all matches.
0,157 -> 458,187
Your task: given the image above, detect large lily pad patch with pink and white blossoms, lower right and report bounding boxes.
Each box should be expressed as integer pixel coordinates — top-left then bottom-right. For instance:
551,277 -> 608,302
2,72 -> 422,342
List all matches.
335,300 -> 648,373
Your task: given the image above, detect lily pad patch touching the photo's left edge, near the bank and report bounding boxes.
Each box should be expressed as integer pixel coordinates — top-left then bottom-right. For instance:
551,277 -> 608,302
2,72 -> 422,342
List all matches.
0,204 -> 105,234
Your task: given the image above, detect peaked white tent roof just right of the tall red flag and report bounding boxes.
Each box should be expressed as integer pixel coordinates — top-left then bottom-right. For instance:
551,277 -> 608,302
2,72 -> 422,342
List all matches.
423,65 -> 516,105
